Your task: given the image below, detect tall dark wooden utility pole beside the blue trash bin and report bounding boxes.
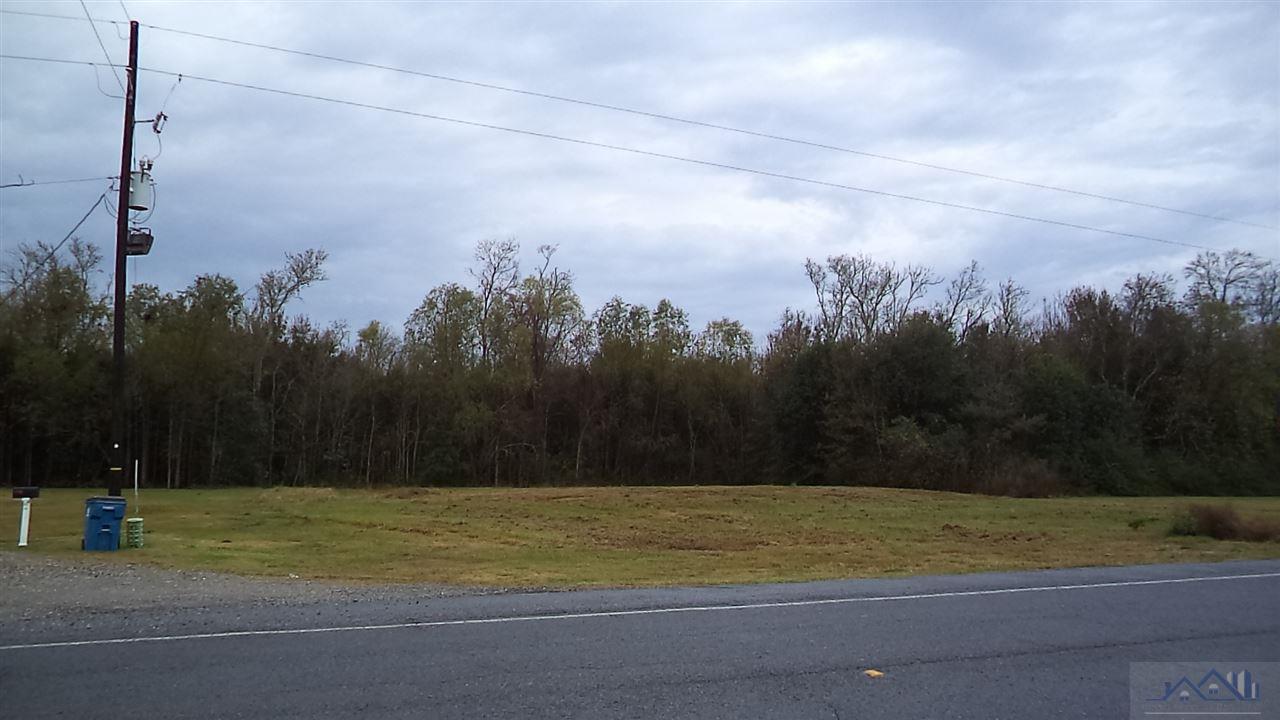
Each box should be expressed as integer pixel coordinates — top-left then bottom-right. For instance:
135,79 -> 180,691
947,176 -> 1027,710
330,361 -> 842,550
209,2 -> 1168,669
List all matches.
106,20 -> 138,496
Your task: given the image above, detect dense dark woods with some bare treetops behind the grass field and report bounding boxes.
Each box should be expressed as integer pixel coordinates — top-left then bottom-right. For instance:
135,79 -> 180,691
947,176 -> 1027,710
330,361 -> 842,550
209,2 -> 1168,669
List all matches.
0,241 -> 1280,495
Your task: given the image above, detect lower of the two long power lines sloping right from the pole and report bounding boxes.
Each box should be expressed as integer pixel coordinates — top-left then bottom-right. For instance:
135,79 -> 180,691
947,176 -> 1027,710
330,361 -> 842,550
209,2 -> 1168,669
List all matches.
0,55 -> 1216,251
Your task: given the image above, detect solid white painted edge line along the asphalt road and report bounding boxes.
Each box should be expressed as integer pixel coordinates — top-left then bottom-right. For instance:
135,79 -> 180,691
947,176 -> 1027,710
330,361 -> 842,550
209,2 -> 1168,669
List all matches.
0,573 -> 1280,652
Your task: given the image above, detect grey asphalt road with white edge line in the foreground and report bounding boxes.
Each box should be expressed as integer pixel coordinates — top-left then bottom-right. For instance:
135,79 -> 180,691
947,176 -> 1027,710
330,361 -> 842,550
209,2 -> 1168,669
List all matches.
0,561 -> 1280,719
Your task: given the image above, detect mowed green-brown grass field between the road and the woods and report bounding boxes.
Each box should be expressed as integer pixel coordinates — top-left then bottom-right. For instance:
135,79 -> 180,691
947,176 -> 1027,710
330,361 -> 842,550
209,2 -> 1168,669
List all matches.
0,487 -> 1280,587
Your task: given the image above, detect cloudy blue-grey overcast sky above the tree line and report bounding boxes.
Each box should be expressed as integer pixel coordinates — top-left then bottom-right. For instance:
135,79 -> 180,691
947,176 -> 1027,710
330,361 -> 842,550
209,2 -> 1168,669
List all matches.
0,0 -> 1280,341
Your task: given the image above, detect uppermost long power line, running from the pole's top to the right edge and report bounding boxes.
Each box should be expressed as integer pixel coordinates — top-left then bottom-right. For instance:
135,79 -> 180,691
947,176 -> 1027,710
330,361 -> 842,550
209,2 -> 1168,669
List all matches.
0,10 -> 1280,229
